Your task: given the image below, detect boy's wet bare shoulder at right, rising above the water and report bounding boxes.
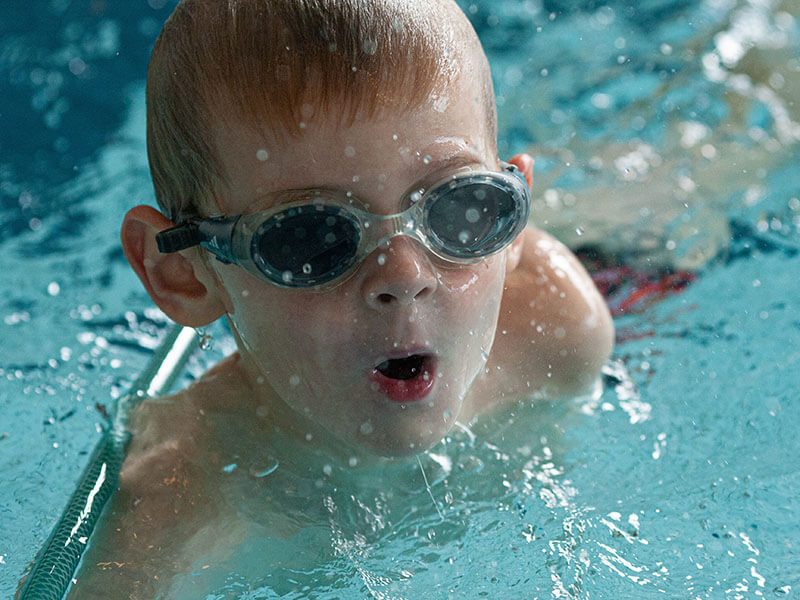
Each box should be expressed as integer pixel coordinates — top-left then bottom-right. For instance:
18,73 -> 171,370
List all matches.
468,227 -> 614,410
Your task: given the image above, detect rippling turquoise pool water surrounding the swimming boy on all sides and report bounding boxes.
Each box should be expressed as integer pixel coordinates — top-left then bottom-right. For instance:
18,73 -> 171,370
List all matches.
0,0 -> 800,598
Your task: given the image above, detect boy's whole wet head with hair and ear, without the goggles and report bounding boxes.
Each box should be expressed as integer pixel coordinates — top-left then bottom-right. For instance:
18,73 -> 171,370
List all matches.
123,0 -> 532,456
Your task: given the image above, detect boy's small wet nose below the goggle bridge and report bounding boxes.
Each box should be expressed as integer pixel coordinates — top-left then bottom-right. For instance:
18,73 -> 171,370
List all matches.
363,236 -> 438,310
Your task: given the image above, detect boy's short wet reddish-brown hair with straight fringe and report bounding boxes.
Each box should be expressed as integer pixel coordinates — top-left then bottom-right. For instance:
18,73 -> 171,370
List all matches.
147,0 -> 496,221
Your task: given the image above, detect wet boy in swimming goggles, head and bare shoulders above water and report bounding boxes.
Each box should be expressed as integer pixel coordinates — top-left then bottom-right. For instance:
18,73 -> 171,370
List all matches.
72,0 -> 613,598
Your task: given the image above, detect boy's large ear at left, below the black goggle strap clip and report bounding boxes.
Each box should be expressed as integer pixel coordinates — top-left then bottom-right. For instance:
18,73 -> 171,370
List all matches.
121,205 -> 225,327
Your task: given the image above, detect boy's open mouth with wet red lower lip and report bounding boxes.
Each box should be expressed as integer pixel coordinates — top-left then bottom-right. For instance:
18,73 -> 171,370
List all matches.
371,354 -> 436,402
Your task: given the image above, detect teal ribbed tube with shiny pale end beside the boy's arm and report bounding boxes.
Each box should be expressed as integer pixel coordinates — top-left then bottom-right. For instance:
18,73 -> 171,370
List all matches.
19,325 -> 197,600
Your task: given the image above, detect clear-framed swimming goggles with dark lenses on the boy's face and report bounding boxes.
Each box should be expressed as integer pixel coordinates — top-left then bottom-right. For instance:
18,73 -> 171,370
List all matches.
156,163 -> 531,288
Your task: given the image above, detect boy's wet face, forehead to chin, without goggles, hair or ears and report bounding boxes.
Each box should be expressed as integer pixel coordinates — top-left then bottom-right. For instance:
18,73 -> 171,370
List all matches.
203,72 -> 506,456
